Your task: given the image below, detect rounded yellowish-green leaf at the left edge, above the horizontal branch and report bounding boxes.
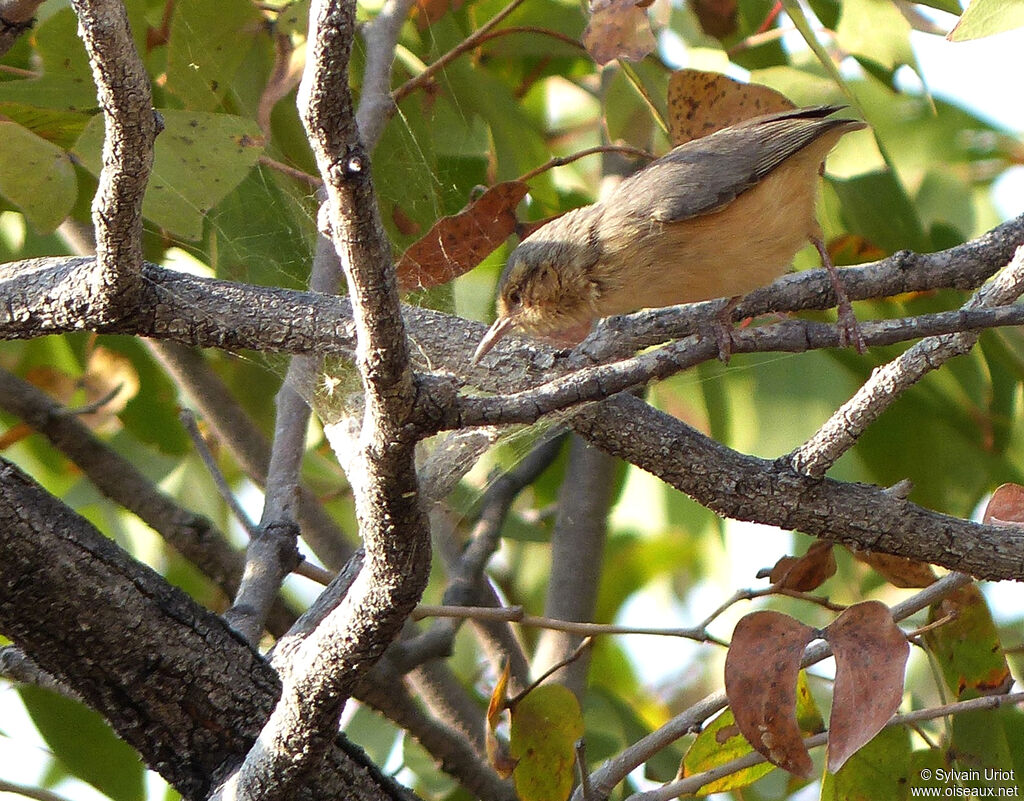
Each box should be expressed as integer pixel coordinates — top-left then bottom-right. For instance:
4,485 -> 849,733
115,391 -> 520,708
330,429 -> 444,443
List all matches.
0,120 -> 78,234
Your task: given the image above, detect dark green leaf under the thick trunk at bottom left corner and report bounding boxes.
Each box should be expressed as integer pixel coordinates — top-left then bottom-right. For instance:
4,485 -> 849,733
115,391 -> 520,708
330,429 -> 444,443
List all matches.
17,685 -> 145,801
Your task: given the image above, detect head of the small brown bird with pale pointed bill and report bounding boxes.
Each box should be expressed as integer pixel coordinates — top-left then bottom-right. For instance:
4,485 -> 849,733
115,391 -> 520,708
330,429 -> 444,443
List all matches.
473,213 -> 600,364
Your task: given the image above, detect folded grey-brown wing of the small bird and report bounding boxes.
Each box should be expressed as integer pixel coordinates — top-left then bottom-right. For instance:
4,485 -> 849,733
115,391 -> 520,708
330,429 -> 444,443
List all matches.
617,106 -> 863,222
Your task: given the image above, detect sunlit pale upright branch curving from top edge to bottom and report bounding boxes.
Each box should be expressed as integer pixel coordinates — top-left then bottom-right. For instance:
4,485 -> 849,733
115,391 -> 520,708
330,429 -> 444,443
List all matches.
222,0 -> 430,800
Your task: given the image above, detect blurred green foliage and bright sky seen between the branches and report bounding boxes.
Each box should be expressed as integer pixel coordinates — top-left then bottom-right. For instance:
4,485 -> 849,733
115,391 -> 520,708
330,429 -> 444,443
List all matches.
0,0 -> 1024,801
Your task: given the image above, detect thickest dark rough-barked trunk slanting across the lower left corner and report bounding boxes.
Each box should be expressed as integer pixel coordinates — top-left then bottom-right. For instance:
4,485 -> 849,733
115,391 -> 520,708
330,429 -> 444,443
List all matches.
0,461 -> 411,801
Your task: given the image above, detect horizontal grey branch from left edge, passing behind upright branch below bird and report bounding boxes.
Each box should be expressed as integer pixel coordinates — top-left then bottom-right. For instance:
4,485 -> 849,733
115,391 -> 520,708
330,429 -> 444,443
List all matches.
0,215 -> 1024,372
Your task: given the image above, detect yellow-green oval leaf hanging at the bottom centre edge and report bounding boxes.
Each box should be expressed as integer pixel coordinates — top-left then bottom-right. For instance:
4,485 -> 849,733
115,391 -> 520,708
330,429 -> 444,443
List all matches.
509,684 -> 583,801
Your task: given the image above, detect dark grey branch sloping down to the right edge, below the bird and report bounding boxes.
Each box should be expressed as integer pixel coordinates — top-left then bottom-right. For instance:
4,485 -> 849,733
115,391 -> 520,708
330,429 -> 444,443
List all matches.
571,394 -> 1024,581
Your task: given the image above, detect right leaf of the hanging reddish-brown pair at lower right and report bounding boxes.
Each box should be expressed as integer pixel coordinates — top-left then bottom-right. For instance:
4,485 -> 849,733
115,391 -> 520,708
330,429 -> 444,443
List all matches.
824,601 -> 910,773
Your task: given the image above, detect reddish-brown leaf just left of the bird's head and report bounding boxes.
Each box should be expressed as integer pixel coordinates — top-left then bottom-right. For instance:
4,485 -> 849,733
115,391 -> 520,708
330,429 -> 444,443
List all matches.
397,181 -> 528,292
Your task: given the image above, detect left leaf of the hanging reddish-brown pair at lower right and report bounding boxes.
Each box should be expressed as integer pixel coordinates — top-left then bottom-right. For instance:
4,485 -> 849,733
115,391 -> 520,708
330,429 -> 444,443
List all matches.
725,610 -> 815,777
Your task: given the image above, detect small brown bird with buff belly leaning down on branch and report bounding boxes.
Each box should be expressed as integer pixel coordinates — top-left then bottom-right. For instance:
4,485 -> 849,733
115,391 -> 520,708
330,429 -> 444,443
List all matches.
473,106 -> 865,364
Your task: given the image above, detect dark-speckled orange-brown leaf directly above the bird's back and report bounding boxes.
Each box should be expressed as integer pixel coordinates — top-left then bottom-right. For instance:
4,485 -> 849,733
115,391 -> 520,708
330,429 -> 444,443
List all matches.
669,70 -> 796,145
